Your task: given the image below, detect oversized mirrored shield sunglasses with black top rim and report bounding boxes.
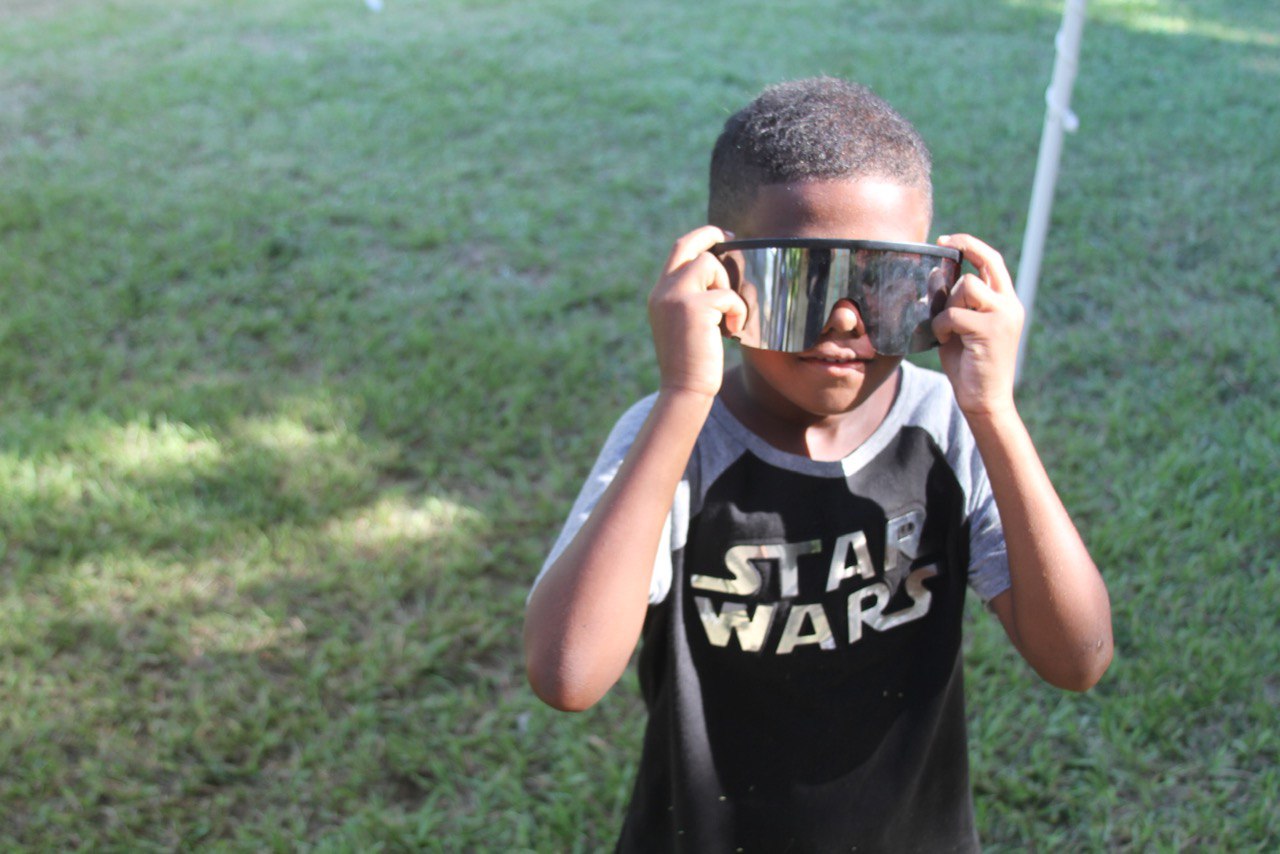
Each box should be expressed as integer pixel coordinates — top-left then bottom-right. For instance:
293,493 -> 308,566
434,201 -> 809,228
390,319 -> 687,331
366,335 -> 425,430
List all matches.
712,238 -> 963,356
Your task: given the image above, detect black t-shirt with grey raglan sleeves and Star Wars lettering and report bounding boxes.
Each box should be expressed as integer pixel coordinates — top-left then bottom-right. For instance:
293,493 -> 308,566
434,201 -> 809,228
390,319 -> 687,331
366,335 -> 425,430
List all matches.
532,362 -> 1009,851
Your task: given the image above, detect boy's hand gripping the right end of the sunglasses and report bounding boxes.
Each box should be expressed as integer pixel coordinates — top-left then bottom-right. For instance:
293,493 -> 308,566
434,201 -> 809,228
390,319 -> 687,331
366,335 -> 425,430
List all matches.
933,234 -> 1024,415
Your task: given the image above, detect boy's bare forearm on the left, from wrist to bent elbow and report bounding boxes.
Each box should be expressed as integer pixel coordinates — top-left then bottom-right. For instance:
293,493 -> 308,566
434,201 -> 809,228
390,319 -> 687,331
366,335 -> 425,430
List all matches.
525,392 -> 712,711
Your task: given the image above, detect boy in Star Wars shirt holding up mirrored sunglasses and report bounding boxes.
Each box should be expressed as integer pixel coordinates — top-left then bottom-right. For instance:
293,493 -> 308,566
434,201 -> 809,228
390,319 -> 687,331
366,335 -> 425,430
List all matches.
525,79 -> 1112,851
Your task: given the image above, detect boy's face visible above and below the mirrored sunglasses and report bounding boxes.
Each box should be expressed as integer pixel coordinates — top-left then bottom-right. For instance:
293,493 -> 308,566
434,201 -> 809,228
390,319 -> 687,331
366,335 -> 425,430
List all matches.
735,178 -> 929,417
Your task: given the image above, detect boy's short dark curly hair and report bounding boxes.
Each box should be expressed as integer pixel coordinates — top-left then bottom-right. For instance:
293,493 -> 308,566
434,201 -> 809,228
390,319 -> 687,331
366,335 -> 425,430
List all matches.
708,77 -> 933,229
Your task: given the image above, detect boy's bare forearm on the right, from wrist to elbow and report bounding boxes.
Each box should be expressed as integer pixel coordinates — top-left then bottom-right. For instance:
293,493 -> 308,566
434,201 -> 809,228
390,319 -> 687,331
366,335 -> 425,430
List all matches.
969,407 -> 1112,690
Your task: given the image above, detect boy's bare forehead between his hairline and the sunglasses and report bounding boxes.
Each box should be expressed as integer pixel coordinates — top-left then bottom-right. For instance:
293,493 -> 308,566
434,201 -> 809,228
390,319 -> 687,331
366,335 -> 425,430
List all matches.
735,178 -> 931,243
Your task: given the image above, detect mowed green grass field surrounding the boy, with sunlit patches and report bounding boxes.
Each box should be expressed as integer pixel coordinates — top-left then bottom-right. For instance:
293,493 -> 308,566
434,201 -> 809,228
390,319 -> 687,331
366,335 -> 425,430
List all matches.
0,0 -> 1280,851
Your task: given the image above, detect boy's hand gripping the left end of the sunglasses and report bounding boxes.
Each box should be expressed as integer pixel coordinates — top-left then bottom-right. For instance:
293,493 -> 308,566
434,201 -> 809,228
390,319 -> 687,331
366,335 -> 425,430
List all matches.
649,225 -> 746,397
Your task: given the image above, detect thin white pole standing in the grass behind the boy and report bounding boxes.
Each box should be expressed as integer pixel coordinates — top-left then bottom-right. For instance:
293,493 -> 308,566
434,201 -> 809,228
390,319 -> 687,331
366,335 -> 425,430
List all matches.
1014,0 -> 1085,382
